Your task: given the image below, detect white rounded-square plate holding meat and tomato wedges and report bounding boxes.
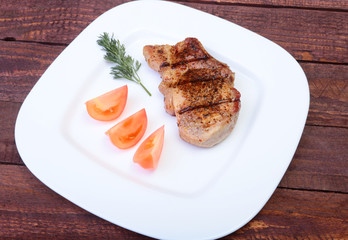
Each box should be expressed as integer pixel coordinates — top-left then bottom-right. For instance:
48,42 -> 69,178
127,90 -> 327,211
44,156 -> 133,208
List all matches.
15,1 -> 309,239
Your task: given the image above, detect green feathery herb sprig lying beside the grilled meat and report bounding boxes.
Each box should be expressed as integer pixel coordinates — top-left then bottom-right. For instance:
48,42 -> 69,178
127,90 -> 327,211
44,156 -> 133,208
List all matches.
97,32 -> 151,96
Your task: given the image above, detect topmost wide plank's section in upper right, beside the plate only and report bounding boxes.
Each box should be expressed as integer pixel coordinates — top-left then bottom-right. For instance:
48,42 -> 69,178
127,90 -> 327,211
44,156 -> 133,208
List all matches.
181,3 -> 348,63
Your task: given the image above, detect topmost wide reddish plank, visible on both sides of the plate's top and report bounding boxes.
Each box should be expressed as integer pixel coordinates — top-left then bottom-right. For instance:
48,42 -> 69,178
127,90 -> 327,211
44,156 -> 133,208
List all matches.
0,0 -> 348,63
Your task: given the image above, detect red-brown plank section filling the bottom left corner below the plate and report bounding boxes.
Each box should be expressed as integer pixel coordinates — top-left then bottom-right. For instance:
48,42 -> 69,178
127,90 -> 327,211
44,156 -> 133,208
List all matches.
0,164 -> 152,239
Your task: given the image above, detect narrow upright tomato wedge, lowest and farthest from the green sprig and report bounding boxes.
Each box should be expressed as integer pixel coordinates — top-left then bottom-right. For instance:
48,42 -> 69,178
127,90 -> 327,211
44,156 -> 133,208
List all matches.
133,125 -> 164,170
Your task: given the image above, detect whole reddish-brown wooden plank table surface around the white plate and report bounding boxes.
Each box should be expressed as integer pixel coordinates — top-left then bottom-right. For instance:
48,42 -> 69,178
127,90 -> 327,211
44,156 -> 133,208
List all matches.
0,0 -> 348,239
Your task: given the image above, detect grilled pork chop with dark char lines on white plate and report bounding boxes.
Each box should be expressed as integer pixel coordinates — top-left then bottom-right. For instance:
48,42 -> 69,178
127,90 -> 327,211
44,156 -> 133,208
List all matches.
143,38 -> 240,147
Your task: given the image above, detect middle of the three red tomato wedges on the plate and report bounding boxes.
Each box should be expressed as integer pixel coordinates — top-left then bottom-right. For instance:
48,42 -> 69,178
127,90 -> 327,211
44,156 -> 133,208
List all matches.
106,108 -> 147,149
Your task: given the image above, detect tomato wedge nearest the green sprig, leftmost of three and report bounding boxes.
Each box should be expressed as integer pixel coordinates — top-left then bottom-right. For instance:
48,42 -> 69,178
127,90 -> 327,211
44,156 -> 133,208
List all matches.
86,85 -> 128,121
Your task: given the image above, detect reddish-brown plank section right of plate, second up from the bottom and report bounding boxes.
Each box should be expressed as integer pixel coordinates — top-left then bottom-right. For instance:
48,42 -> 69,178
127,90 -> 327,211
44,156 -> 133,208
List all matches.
280,126 -> 348,193
